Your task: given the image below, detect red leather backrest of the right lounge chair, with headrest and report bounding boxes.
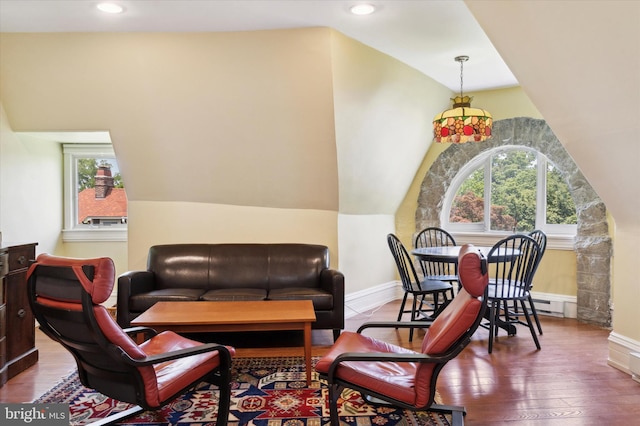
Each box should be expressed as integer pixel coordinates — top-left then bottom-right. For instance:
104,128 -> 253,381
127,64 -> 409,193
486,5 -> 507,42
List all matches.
416,244 -> 489,405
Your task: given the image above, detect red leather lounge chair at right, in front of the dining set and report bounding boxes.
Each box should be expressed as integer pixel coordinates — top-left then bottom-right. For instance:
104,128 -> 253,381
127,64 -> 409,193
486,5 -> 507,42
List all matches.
316,245 -> 488,425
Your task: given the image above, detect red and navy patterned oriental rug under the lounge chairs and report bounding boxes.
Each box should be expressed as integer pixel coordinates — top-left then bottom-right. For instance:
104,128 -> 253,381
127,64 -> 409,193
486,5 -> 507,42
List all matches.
33,357 -> 451,426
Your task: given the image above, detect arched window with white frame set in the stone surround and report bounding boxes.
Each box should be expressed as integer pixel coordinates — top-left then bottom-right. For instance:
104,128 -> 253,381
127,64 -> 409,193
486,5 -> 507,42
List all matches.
441,145 -> 577,235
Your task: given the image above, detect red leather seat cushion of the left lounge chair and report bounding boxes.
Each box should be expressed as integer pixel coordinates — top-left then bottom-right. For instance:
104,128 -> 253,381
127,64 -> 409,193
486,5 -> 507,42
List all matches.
140,331 -> 235,407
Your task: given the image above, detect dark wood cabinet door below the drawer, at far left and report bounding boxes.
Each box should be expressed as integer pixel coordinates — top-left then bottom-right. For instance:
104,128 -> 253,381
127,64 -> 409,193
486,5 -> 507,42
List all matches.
5,269 -> 35,360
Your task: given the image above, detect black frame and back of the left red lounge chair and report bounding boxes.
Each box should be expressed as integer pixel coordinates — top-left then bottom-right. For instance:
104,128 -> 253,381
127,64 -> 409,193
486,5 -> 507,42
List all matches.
27,258 -> 231,426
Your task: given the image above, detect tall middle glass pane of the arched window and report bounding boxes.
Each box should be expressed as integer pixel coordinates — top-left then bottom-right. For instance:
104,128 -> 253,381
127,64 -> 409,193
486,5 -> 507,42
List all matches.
491,150 -> 537,232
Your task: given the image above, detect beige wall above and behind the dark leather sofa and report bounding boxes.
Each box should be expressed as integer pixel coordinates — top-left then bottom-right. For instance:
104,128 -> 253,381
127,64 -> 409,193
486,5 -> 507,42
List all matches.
0,28 -> 338,266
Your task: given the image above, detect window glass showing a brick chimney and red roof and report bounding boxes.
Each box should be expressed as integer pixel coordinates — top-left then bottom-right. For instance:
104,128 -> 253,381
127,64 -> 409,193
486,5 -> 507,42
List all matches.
76,158 -> 127,227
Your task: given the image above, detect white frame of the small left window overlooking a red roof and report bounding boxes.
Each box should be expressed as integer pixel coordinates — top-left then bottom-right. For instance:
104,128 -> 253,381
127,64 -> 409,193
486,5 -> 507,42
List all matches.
62,143 -> 127,242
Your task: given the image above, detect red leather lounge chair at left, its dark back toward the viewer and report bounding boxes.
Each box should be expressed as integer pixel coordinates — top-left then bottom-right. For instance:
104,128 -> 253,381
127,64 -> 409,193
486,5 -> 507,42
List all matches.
28,254 -> 235,426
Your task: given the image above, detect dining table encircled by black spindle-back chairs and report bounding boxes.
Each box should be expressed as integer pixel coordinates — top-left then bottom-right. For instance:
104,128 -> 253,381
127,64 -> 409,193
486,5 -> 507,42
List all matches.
411,246 -> 520,335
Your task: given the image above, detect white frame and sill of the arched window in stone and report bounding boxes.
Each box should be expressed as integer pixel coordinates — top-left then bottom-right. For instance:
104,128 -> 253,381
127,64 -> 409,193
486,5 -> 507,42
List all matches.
440,145 -> 578,250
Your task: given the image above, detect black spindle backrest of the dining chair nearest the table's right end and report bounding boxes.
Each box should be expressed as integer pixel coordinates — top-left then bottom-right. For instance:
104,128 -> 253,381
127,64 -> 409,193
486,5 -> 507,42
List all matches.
488,234 -> 542,299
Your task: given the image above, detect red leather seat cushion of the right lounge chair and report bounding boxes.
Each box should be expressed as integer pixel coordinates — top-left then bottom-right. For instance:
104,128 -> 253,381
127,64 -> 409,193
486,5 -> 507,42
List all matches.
316,331 -> 418,404
